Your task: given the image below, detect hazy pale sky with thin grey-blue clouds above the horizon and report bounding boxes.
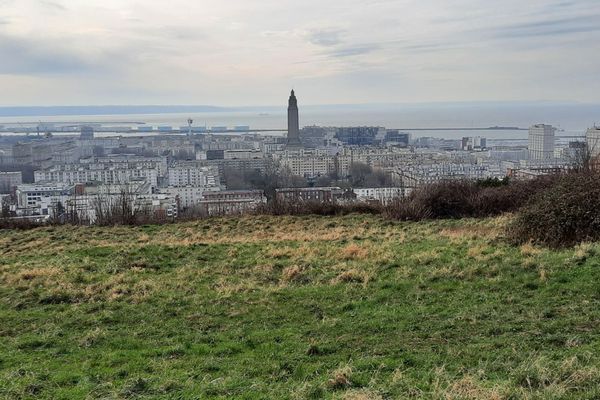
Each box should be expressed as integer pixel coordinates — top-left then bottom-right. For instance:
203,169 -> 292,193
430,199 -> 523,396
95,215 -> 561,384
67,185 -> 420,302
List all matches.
0,0 -> 600,106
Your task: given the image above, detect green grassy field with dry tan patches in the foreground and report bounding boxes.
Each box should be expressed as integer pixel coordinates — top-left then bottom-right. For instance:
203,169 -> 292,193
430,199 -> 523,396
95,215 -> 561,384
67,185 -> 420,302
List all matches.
0,215 -> 600,400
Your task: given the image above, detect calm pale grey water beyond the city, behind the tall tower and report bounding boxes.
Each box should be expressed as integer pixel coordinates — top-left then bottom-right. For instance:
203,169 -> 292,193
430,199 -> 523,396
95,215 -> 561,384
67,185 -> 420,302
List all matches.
0,104 -> 600,141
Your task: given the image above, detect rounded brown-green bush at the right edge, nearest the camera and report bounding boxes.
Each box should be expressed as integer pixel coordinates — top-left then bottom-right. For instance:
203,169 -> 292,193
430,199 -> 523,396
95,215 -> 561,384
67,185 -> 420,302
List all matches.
509,173 -> 600,247
